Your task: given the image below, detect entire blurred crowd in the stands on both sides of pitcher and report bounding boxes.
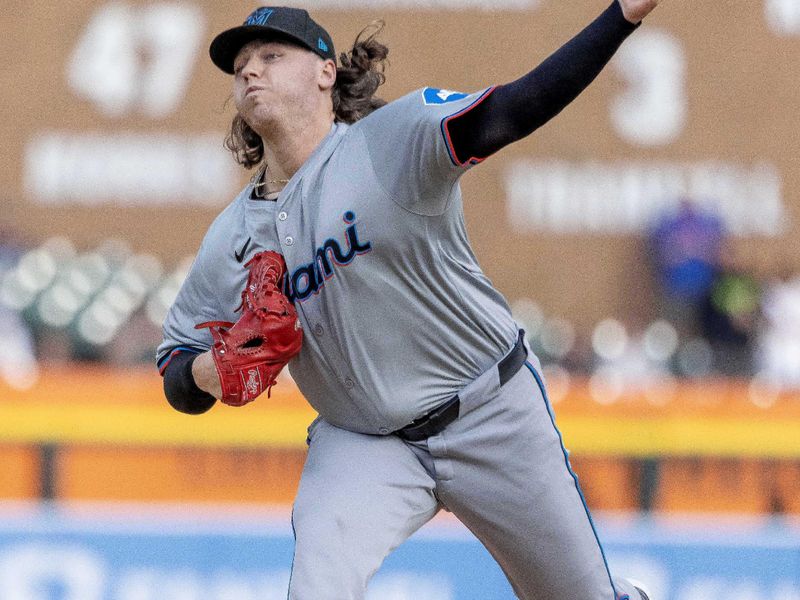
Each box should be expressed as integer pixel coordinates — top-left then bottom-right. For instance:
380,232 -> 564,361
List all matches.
0,199 -> 800,401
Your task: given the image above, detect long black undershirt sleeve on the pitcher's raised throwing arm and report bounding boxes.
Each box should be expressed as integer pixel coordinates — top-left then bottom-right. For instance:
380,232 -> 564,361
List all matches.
447,0 -> 638,164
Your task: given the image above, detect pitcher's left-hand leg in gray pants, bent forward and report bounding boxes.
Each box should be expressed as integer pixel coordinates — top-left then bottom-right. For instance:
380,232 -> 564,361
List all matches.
289,421 -> 437,600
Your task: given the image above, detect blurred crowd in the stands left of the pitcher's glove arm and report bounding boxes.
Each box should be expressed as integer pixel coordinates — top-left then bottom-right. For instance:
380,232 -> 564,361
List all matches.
0,223 -> 191,389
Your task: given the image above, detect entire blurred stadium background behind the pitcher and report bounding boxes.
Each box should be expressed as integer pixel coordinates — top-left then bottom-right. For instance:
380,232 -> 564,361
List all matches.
0,0 -> 800,600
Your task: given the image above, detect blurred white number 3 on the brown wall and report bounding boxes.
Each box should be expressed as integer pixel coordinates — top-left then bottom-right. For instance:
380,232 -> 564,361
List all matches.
611,29 -> 688,146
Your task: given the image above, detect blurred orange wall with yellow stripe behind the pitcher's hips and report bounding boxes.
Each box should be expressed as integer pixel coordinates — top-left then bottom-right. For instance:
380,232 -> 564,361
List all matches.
0,365 -> 800,515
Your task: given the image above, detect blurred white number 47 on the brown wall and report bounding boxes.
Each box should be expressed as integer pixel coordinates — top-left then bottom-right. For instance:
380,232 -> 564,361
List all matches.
67,2 -> 204,118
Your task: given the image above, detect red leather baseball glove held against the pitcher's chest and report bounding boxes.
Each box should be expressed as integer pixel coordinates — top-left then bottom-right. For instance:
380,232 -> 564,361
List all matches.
195,251 -> 303,406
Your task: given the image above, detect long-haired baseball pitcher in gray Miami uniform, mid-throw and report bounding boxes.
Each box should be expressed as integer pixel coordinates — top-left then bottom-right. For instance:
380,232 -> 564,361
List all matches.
157,0 -> 658,600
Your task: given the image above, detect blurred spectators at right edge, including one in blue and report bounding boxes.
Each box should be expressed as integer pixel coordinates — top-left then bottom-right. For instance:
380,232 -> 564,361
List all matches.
647,199 -> 800,387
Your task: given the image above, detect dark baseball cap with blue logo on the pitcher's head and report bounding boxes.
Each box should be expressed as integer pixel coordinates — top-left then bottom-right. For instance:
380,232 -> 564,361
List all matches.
208,6 -> 336,75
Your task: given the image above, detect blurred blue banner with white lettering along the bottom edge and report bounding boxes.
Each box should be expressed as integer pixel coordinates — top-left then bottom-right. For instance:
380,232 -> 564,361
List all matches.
0,505 -> 800,600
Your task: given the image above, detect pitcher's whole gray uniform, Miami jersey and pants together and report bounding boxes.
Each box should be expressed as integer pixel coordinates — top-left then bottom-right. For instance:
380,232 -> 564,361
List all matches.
158,88 -> 648,600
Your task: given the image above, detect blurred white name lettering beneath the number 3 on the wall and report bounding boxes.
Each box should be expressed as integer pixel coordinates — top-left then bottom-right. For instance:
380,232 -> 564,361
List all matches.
505,160 -> 789,236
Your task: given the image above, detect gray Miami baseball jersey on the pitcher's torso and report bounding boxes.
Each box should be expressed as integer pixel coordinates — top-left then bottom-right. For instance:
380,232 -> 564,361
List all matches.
158,88 -> 518,434
